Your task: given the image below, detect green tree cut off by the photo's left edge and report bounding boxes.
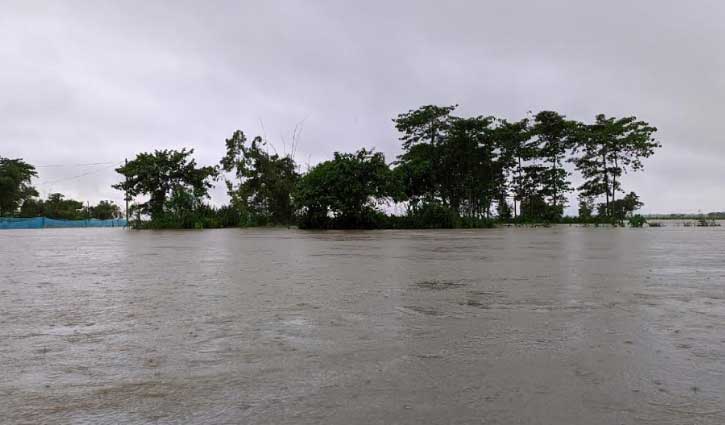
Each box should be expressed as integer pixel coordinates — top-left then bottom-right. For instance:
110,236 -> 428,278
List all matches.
0,157 -> 38,217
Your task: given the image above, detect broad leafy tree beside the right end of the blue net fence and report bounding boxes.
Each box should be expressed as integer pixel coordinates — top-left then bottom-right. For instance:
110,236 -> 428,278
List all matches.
113,148 -> 218,227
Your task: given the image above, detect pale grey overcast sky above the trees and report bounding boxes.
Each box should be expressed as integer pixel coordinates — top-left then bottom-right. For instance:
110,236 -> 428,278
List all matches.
0,0 -> 725,212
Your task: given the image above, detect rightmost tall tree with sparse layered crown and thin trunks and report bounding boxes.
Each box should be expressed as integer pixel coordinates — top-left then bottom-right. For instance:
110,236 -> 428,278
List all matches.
573,114 -> 661,218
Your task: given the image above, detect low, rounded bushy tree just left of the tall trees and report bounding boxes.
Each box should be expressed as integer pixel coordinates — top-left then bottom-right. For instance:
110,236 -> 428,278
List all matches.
294,149 -> 396,228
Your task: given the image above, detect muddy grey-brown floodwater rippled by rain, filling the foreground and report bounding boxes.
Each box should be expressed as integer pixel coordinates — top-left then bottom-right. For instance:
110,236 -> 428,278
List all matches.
0,226 -> 725,425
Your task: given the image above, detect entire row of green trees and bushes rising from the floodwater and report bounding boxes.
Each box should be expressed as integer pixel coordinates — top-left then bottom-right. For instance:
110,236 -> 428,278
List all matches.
0,105 -> 660,229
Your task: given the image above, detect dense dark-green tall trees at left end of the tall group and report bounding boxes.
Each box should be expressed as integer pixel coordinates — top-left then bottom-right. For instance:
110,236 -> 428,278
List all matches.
394,106 -> 510,218
